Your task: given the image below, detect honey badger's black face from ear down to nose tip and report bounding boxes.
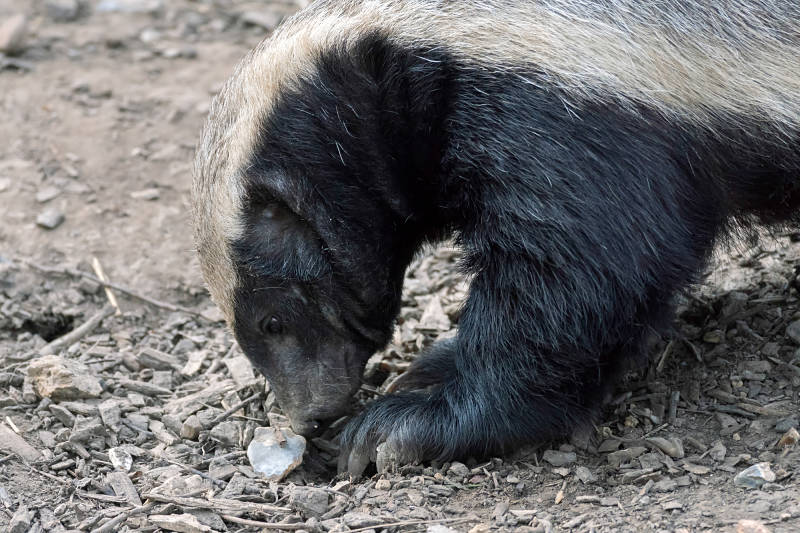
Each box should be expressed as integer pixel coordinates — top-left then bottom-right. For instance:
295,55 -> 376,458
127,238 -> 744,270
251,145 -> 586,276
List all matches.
233,200 -> 392,435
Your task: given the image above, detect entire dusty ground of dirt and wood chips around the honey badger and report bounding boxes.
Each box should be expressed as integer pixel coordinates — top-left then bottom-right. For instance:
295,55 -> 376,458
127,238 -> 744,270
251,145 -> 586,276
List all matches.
0,0 -> 800,533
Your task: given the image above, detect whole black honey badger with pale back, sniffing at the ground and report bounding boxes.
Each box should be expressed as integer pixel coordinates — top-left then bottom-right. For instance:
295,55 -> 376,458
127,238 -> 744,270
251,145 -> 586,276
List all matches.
193,0 -> 800,474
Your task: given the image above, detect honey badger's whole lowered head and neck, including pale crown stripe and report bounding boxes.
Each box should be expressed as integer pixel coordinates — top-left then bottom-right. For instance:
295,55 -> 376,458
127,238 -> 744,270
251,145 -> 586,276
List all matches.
193,7 -> 446,434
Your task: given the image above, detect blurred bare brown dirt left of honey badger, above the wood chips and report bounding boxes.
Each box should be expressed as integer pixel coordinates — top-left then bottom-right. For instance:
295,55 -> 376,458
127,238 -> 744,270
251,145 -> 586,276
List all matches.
0,0 -> 306,304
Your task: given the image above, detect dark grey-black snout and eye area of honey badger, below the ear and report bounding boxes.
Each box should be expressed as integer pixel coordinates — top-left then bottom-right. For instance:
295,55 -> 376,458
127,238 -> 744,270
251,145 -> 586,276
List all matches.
228,276 -> 388,436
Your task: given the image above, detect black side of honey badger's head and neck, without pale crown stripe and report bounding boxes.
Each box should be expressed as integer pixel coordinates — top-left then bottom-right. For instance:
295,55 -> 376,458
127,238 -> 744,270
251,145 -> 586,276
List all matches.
225,36 -> 454,433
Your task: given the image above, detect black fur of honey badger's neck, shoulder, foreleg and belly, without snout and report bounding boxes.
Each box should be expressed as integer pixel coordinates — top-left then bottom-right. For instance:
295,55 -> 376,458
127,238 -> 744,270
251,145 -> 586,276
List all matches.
231,31 -> 800,472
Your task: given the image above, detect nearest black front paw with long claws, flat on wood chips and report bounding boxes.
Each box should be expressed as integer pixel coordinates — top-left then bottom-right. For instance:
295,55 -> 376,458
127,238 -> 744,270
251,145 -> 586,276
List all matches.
339,358 -> 591,477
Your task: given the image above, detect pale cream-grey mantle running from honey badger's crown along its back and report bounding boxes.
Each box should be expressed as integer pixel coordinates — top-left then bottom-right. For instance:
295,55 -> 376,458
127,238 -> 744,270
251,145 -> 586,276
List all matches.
195,0 -> 800,320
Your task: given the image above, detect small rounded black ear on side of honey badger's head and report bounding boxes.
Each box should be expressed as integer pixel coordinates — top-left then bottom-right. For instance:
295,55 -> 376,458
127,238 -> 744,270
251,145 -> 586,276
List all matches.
236,196 -> 330,281
